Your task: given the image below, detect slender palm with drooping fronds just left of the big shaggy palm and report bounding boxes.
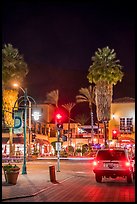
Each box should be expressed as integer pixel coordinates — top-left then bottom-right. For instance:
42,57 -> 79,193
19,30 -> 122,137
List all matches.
76,85 -> 95,143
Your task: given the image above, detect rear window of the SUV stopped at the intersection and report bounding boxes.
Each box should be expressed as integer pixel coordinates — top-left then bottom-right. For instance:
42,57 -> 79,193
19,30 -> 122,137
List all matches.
97,150 -> 126,160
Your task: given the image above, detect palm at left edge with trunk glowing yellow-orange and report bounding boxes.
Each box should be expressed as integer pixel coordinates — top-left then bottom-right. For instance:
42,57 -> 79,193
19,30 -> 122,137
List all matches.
2,44 -> 28,156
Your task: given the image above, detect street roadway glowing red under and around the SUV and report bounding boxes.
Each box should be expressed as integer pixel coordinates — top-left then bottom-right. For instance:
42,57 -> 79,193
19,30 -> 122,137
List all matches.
3,160 -> 135,202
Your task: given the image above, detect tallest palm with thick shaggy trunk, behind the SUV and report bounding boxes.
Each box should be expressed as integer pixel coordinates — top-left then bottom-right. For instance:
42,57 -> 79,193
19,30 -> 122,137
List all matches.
87,46 -> 124,146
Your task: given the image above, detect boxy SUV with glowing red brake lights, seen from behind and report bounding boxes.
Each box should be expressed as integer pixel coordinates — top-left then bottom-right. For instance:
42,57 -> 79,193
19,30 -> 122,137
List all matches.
93,148 -> 133,183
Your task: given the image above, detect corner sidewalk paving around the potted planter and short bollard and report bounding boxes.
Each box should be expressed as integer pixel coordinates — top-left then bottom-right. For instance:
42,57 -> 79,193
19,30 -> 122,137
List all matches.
2,163 -> 72,201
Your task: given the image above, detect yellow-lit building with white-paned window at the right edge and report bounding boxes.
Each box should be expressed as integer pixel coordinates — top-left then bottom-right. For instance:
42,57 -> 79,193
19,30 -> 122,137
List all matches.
109,97 -> 135,147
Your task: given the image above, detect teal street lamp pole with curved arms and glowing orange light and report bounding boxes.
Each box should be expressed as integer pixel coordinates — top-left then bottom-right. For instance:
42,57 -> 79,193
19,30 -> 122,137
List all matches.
13,84 -> 39,174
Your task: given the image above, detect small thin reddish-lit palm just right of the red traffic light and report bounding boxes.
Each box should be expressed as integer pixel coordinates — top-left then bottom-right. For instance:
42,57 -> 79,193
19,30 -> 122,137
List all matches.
62,103 -> 76,146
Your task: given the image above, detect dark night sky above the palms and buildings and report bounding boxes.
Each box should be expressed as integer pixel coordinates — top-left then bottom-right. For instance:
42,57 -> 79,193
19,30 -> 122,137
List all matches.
2,0 -> 135,108
